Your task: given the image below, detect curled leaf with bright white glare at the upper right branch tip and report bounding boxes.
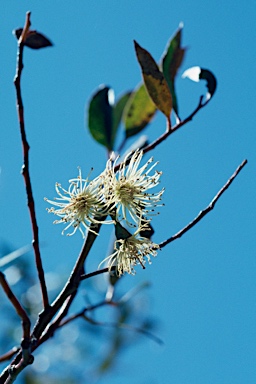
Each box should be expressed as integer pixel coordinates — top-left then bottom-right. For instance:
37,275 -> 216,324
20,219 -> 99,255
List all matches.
182,67 -> 217,100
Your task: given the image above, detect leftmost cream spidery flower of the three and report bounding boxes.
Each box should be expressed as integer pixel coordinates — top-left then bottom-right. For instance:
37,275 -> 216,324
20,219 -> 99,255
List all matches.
45,168 -> 113,237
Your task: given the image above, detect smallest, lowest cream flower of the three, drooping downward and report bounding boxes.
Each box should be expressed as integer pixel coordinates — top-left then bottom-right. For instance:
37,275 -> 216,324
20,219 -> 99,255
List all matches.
100,226 -> 159,276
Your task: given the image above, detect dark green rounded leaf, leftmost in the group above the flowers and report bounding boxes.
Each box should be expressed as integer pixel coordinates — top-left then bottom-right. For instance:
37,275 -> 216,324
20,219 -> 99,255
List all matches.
88,86 -> 113,151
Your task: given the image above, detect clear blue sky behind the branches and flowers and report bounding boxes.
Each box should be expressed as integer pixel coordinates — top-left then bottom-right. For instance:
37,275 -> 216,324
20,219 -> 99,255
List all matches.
0,0 -> 256,384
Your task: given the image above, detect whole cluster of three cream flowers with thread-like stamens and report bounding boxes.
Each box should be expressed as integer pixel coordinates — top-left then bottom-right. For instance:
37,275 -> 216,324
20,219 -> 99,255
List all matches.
45,150 -> 164,276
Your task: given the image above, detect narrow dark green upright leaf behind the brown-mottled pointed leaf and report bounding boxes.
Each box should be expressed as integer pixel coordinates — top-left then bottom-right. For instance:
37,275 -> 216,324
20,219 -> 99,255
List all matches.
160,24 -> 186,115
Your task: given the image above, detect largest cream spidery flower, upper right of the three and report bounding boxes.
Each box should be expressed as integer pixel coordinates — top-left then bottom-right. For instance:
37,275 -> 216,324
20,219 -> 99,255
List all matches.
102,150 -> 164,226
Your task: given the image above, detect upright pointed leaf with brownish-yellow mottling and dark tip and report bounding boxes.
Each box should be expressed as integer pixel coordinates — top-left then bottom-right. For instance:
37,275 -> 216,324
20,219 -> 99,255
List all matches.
134,41 -> 172,119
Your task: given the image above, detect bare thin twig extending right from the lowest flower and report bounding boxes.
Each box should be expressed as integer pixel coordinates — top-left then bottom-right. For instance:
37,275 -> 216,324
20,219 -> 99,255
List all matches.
159,160 -> 247,248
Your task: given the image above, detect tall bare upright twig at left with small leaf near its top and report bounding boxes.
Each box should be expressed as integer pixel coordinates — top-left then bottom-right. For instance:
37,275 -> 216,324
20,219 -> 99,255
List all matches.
14,12 -> 49,308
